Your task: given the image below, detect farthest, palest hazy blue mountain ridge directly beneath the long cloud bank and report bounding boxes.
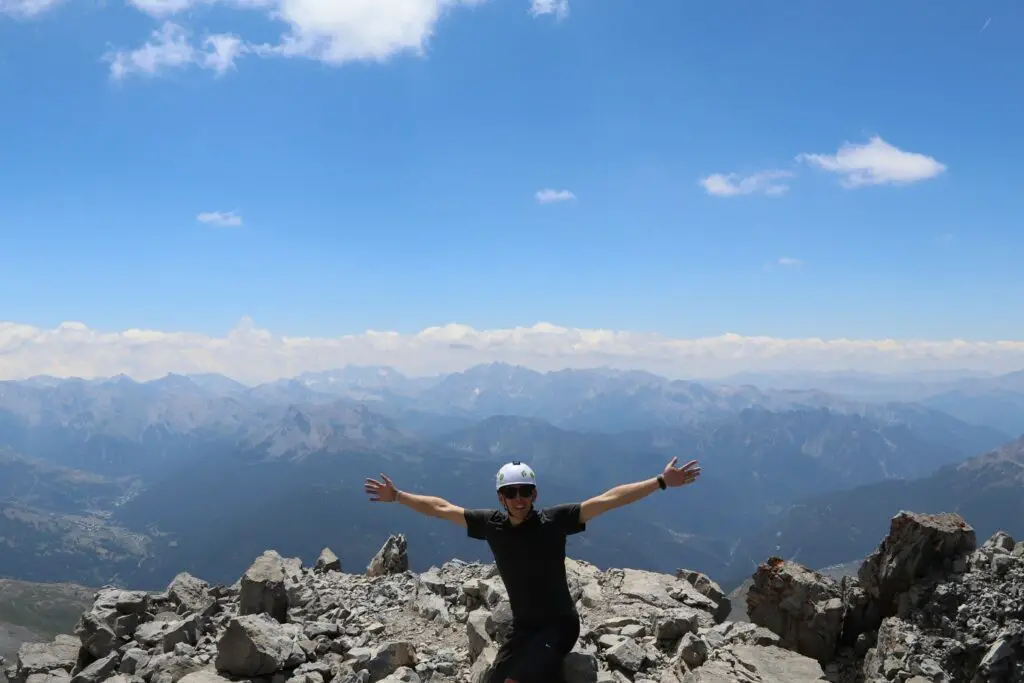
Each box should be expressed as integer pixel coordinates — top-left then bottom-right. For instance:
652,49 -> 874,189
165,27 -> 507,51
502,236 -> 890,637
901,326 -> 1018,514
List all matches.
9,362 -> 1024,436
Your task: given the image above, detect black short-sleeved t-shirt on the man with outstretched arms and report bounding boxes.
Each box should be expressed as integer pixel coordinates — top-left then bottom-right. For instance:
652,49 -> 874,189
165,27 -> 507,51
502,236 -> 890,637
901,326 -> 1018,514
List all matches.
466,503 -> 587,623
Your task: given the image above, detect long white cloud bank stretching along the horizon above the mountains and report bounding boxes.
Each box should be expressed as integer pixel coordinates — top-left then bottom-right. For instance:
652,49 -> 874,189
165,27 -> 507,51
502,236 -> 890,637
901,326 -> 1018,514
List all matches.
0,319 -> 1024,383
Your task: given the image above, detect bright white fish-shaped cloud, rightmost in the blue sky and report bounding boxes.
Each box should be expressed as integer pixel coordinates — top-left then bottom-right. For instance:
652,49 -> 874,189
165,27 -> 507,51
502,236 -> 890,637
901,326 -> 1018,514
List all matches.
797,135 -> 946,188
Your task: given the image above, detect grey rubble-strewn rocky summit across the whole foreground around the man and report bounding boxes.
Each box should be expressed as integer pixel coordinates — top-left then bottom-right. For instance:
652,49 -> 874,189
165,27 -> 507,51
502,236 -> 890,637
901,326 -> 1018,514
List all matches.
0,513 -> 1024,683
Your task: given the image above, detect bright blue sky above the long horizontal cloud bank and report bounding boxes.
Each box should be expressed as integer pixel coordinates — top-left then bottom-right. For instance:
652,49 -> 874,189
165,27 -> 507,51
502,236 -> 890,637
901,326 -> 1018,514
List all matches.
0,0 -> 1024,350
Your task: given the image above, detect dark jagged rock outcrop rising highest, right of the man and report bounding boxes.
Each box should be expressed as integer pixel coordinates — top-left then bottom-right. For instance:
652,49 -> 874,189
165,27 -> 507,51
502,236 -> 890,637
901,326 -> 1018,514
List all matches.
746,512 -> 1024,683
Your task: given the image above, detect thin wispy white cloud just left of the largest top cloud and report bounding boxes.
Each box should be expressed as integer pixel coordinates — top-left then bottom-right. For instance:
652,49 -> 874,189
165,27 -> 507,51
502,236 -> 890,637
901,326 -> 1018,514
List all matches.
105,22 -> 248,80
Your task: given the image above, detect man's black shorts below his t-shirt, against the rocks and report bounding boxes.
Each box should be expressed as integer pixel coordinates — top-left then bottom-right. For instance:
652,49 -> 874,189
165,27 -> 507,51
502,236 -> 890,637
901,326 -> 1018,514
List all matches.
487,618 -> 580,683
